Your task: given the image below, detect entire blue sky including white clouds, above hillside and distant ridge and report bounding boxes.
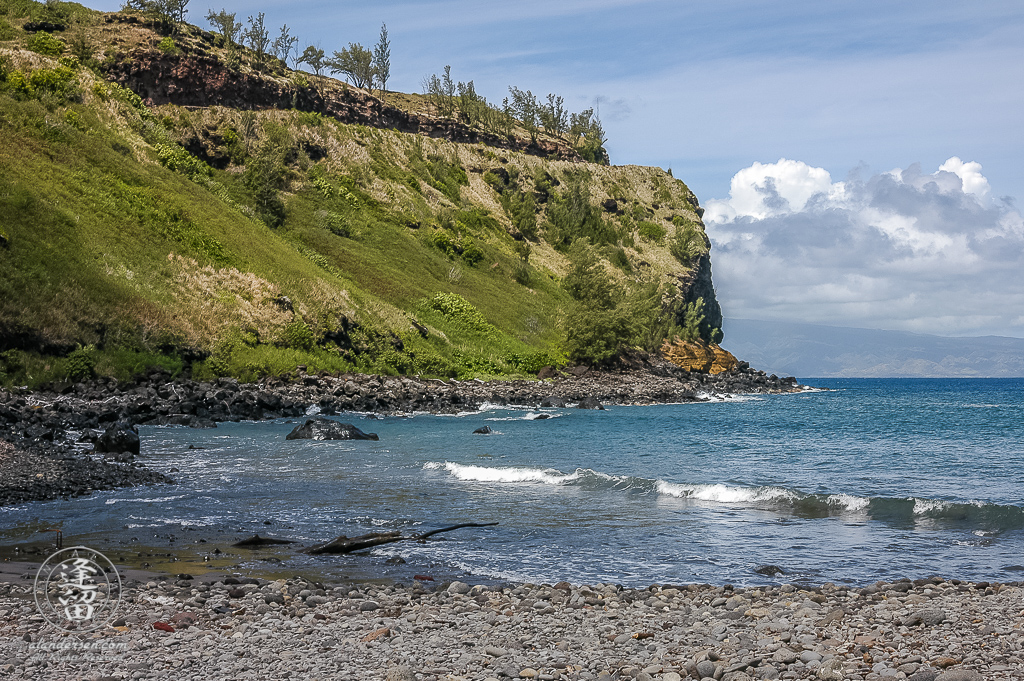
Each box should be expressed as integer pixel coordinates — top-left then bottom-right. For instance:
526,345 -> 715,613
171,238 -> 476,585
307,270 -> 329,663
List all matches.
94,0 -> 1024,337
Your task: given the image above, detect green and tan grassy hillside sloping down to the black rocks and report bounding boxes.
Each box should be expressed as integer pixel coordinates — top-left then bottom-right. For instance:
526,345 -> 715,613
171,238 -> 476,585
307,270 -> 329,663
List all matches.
0,1 -> 717,385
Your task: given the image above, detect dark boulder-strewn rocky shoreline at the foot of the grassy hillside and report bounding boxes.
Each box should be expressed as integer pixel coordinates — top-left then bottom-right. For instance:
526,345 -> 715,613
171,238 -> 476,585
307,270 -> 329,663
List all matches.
0,358 -> 804,506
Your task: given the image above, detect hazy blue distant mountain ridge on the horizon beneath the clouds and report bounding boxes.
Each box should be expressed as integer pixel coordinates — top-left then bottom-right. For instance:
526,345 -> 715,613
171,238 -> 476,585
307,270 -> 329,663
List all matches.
723,318 -> 1024,378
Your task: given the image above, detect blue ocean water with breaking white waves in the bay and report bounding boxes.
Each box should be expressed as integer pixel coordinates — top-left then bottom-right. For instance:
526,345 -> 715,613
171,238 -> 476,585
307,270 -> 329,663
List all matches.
0,379 -> 1024,586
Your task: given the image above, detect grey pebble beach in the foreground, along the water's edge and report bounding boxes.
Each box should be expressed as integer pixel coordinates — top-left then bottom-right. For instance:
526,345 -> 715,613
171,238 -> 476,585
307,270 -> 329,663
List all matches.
0,576 -> 1024,681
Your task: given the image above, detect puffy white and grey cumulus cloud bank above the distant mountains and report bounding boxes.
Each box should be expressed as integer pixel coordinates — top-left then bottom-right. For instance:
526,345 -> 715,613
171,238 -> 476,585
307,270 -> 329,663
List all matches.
705,157 -> 1024,336
